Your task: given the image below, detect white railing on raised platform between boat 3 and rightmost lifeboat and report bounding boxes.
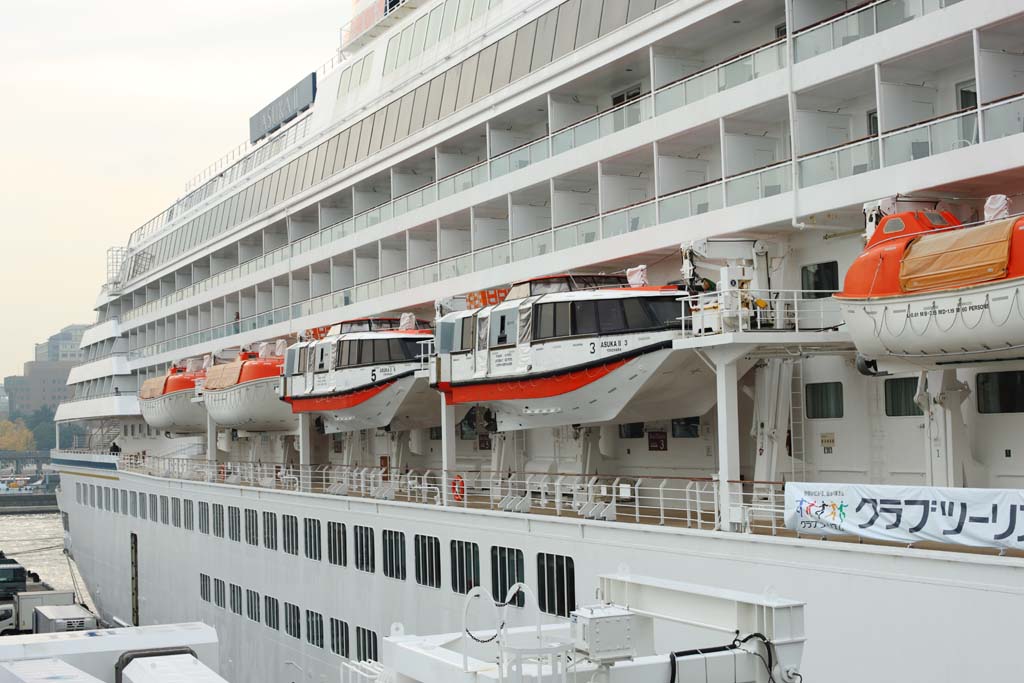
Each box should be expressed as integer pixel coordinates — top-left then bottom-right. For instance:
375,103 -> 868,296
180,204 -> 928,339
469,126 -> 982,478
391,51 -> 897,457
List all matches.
683,289 -> 843,337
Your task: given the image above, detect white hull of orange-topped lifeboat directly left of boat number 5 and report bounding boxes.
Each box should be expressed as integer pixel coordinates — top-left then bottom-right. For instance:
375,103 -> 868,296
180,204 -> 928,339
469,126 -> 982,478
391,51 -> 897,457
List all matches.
204,377 -> 297,431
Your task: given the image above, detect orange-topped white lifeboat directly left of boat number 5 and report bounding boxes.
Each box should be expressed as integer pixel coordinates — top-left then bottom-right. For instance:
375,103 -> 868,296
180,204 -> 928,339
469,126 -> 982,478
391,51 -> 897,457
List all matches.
203,340 -> 296,431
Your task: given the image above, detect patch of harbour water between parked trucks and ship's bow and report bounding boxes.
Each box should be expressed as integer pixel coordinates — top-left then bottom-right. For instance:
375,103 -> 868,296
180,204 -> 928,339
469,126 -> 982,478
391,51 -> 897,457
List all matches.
0,513 -> 92,609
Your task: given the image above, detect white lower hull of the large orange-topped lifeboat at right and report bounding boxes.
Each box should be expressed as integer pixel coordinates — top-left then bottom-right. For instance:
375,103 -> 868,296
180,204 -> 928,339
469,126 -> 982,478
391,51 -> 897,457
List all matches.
837,278 -> 1024,368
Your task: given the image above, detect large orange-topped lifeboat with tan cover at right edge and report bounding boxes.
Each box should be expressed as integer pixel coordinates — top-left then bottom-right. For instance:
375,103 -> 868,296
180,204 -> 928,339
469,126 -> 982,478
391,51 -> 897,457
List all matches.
835,211 -> 1024,371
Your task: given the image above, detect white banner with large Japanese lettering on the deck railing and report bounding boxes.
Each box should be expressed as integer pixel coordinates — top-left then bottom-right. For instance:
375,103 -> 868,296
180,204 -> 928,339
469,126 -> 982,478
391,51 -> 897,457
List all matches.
785,481 -> 1024,550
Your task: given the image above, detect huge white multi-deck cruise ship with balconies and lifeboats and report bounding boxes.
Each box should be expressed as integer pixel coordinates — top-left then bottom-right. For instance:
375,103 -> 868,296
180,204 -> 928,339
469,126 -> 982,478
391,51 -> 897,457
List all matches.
52,0 -> 1024,683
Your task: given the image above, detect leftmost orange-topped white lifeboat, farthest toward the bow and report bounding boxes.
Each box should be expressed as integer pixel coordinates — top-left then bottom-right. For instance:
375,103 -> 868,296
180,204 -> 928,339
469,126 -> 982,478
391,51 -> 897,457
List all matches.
138,358 -> 207,434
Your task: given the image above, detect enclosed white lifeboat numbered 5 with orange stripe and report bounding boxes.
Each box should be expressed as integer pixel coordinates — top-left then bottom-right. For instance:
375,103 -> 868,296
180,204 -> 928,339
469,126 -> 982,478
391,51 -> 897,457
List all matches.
282,318 -> 440,433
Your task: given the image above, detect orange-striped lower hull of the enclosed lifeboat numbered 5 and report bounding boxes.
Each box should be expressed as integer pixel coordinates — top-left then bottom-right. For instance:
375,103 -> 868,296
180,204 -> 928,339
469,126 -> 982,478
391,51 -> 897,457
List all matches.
289,372 -> 441,433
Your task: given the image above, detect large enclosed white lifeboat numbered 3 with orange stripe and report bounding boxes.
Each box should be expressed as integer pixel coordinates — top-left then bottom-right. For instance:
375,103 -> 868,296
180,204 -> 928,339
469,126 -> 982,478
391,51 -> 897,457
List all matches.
431,275 -> 715,431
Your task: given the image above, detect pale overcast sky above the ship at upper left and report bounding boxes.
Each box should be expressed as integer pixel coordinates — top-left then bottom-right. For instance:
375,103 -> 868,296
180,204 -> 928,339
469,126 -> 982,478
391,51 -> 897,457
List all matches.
0,0 -> 349,381
